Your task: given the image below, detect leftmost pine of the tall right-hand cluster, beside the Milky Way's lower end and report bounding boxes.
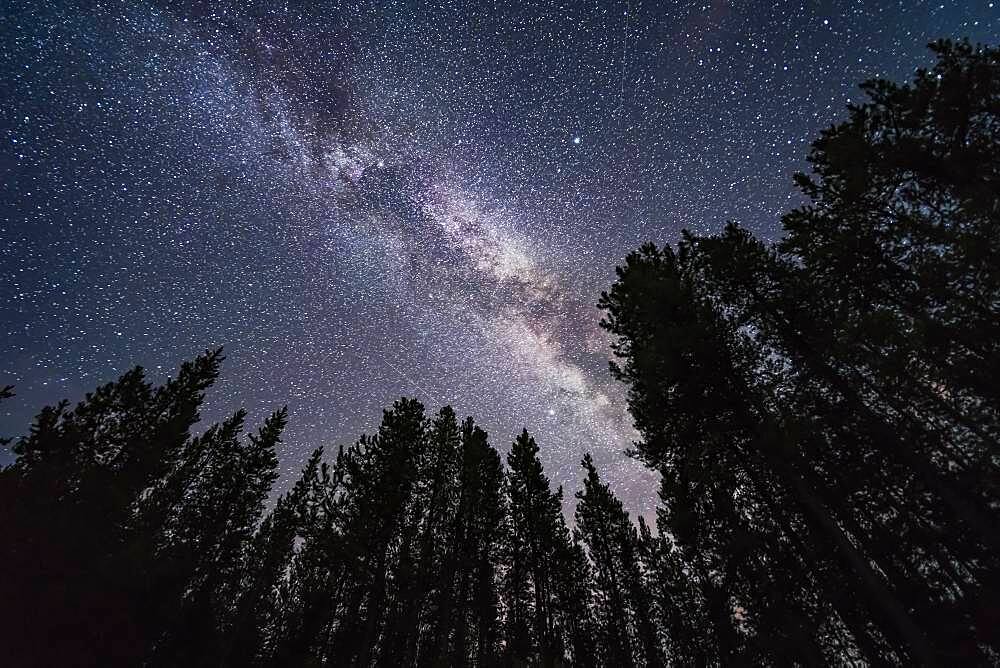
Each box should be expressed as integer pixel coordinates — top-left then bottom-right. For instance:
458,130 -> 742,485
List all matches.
602,241 -> 934,661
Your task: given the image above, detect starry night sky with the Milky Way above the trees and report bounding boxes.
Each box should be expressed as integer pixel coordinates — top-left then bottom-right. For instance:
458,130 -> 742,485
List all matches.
0,0 -> 1000,513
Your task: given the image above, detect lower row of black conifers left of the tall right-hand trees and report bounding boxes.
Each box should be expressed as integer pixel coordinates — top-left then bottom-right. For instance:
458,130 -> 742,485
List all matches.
0,351 -> 661,666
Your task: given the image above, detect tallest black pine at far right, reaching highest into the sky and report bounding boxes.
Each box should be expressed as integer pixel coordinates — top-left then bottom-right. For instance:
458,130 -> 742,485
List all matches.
777,41 -> 1000,661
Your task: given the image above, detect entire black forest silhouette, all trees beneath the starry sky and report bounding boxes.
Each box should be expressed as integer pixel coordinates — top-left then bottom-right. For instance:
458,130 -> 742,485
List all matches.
0,41 -> 1000,666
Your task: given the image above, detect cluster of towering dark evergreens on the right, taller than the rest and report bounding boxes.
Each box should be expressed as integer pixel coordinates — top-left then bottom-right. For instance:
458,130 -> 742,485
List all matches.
602,42 -> 1000,663
